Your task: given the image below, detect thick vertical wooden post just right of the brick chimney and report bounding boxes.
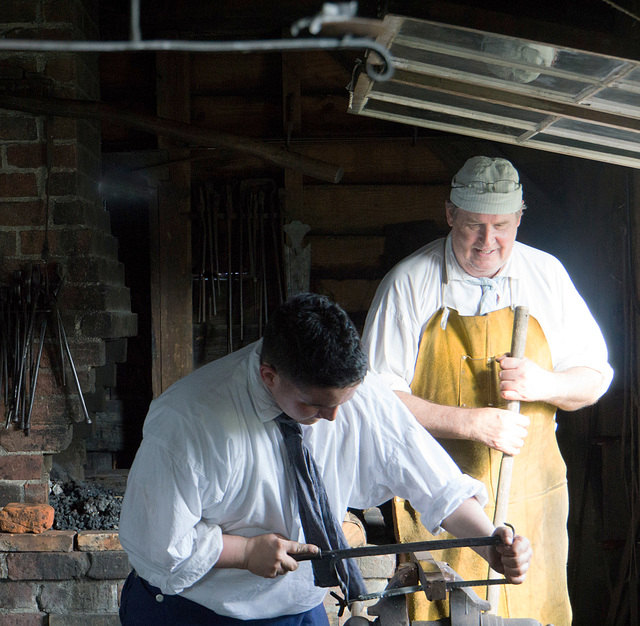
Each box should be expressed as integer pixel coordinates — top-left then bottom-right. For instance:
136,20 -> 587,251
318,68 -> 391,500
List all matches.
150,52 -> 193,397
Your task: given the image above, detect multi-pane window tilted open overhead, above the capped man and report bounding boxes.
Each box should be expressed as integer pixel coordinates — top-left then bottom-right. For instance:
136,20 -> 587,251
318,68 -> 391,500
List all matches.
349,15 -> 640,168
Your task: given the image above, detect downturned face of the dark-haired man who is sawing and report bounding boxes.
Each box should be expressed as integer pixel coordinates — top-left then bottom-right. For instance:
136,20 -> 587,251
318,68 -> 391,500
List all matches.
260,364 -> 359,425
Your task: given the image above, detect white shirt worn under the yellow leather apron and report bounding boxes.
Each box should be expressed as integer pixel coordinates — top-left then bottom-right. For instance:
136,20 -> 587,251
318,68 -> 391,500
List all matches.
363,235 -> 613,394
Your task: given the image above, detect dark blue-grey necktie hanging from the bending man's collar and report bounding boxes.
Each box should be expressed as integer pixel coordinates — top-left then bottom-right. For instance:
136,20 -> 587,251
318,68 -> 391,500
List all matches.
276,413 -> 367,602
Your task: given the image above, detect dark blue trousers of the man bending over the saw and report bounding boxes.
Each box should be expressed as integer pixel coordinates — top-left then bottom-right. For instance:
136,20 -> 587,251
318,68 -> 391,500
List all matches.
120,572 -> 329,626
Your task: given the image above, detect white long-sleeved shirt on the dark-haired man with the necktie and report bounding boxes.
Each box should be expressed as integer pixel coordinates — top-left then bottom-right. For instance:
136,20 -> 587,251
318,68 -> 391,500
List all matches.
120,342 -> 486,620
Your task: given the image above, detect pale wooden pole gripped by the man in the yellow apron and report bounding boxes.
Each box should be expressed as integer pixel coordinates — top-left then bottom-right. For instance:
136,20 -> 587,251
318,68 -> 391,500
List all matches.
487,306 -> 529,614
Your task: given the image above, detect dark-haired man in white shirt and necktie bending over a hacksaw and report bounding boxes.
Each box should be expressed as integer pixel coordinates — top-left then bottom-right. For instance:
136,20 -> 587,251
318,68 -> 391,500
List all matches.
120,294 -> 531,626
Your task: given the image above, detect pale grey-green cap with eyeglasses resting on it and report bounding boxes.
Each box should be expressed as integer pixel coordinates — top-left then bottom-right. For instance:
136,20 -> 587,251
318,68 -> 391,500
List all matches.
449,156 -> 522,215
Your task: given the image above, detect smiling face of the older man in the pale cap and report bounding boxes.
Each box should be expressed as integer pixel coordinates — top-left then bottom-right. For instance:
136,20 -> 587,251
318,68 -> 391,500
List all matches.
447,204 -> 522,278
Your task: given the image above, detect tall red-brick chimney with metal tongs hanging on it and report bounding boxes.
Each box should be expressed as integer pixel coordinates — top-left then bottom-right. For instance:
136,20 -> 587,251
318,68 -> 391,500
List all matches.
0,0 -> 137,500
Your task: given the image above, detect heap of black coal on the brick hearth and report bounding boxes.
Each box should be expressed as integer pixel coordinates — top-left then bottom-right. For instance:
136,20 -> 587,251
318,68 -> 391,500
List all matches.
49,480 -> 122,530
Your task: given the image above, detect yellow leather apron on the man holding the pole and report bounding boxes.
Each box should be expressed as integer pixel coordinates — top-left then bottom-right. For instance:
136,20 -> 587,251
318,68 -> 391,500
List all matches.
393,308 -> 571,626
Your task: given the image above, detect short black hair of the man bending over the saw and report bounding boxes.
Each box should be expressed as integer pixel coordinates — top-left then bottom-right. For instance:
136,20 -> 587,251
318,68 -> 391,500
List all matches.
260,293 -> 367,389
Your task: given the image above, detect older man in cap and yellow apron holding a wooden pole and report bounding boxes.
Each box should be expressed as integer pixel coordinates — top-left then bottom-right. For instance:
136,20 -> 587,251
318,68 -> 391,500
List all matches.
364,157 -> 613,626
